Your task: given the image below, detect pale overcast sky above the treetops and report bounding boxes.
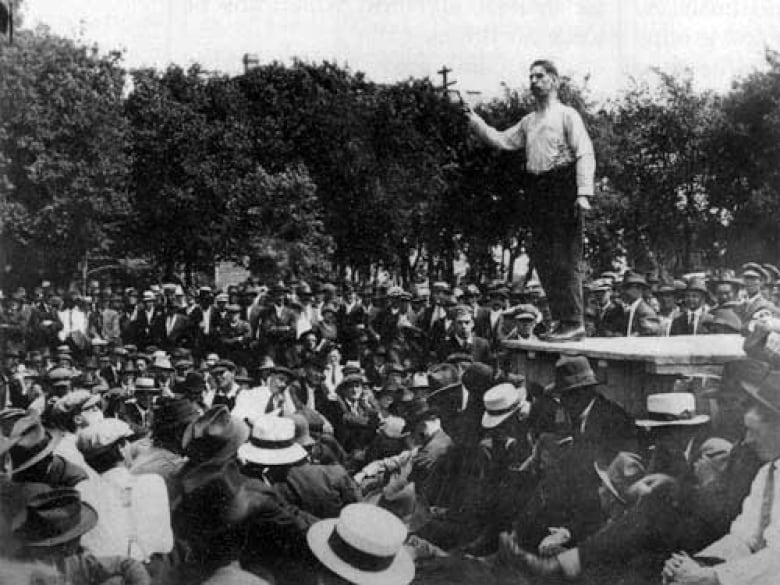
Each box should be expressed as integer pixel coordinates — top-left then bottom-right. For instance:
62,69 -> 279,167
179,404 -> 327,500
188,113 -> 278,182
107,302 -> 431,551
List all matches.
19,0 -> 780,97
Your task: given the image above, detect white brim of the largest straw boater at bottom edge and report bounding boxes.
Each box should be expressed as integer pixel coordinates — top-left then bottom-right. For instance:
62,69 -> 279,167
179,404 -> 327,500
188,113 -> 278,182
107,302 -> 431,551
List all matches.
306,518 -> 414,585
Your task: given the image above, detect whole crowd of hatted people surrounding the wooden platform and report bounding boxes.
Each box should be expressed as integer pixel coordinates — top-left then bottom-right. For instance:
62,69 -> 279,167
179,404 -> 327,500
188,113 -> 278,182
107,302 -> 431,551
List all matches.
0,263 -> 780,585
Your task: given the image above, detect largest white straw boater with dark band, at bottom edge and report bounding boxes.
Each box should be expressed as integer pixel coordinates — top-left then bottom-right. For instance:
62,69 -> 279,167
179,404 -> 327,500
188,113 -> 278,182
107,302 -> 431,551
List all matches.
306,503 -> 414,585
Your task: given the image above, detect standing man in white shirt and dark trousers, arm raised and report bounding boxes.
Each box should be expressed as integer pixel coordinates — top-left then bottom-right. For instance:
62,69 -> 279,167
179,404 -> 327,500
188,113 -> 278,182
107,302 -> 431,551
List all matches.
460,60 -> 596,341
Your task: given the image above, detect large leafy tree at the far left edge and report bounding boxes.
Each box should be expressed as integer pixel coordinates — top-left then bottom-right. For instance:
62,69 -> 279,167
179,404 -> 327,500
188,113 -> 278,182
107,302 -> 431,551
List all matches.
0,29 -> 129,284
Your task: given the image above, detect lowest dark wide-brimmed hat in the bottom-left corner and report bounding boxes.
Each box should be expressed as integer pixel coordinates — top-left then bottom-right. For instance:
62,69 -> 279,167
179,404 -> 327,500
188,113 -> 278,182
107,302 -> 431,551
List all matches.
14,488 -> 98,547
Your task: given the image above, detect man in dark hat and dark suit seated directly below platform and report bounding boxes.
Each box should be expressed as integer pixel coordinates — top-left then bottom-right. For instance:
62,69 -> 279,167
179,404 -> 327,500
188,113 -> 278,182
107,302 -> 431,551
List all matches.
515,356 -> 637,550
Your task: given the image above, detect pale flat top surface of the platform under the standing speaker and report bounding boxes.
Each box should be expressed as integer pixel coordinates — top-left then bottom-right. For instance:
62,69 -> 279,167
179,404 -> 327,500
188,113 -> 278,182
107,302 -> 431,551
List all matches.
504,335 -> 745,365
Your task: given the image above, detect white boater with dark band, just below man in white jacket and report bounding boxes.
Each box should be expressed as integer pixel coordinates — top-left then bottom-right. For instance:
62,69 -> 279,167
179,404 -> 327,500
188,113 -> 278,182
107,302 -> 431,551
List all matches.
238,414 -> 307,465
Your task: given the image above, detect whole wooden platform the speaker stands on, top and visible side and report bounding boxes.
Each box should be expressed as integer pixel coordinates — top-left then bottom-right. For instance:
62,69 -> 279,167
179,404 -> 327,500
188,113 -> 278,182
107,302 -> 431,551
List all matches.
504,335 -> 745,415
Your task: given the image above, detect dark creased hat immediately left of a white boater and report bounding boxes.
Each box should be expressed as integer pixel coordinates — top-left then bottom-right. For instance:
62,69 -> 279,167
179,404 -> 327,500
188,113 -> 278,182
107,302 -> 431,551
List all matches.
182,404 -> 249,463
